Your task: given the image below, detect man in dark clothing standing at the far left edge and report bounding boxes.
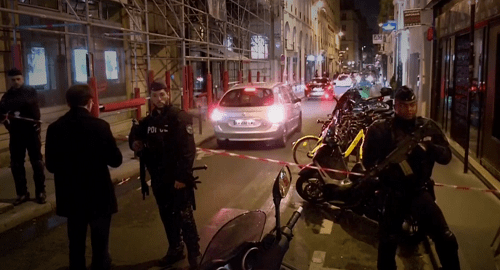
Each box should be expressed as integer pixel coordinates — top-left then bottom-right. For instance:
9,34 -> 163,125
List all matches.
0,69 -> 47,205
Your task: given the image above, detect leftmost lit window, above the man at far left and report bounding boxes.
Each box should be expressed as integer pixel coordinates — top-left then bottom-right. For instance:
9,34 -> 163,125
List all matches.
27,47 -> 47,87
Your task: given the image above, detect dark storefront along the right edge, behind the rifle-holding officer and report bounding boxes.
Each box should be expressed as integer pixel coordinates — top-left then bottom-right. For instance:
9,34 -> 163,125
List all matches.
432,0 -> 500,178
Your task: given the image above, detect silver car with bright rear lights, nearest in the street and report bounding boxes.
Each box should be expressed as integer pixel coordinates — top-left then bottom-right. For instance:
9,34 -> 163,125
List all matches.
210,82 -> 302,147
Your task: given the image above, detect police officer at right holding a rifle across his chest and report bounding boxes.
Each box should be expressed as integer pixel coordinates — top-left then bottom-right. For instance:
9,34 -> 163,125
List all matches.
363,86 -> 460,270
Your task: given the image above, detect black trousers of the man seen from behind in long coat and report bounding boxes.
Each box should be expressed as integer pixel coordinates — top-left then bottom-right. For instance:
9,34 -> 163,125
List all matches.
68,215 -> 111,270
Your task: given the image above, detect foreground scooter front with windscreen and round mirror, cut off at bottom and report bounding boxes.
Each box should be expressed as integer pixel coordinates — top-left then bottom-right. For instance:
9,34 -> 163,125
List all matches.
199,166 -> 302,270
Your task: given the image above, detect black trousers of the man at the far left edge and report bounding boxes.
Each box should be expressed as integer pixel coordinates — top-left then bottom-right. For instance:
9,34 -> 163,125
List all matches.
9,128 -> 45,196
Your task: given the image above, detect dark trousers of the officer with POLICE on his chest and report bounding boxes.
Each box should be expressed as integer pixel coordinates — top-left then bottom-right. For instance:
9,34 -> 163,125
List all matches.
151,177 -> 200,256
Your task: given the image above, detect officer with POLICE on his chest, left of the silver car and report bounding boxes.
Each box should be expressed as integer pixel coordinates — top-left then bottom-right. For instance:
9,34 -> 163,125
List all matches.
132,82 -> 201,269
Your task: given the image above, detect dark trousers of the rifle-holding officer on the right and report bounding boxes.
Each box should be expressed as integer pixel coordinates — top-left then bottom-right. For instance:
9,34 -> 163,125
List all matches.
377,191 -> 460,270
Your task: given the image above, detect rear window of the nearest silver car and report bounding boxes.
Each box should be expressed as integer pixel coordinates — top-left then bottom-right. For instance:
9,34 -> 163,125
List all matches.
219,88 -> 274,107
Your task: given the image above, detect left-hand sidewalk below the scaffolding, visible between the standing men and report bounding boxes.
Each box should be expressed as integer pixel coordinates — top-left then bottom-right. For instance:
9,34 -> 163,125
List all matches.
0,112 -> 214,233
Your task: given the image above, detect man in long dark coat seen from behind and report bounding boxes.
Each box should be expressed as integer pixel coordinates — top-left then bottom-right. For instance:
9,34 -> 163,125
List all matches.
45,85 -> 122,270
